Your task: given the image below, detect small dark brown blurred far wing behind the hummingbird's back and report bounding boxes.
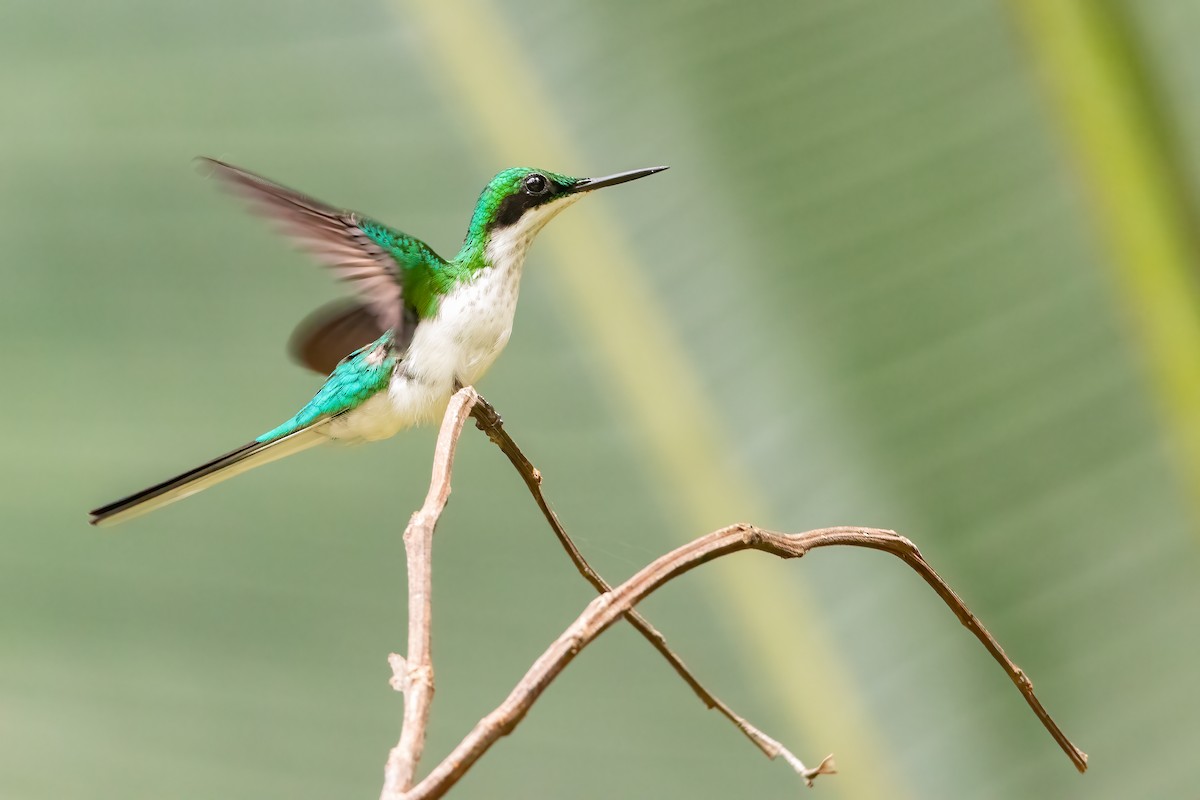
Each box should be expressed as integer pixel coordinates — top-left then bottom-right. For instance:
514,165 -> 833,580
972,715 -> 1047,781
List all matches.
288,299 -> 416,375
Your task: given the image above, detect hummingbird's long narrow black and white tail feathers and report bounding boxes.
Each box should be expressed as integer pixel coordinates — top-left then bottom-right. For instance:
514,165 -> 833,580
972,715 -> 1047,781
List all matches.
90,420 -> 325,525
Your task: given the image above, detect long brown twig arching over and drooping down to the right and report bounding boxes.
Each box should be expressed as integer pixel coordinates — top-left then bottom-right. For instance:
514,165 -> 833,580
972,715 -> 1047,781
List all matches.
403,524 -> 1087,800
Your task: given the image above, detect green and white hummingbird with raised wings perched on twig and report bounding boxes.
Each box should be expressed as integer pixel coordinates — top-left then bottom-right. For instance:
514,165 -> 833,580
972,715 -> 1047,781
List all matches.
90,158 -> 666,525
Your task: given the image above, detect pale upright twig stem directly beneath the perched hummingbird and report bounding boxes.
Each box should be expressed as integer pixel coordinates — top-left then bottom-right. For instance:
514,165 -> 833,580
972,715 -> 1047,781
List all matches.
380,386 -> 479,800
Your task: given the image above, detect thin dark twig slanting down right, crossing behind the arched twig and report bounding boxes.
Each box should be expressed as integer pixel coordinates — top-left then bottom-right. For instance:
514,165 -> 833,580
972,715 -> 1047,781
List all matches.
470,396 -> 820,781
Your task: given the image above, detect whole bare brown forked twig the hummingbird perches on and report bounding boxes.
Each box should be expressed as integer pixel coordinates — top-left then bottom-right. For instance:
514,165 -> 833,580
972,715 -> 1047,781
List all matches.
382,387 -> 1087,800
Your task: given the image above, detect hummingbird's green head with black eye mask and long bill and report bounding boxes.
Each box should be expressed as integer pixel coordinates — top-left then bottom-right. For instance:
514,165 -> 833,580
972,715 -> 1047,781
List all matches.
463,167 -> 666,263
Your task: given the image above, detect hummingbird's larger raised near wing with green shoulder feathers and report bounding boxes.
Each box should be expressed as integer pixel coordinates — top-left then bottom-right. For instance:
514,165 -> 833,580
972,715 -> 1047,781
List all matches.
200,158 -> 444,333
